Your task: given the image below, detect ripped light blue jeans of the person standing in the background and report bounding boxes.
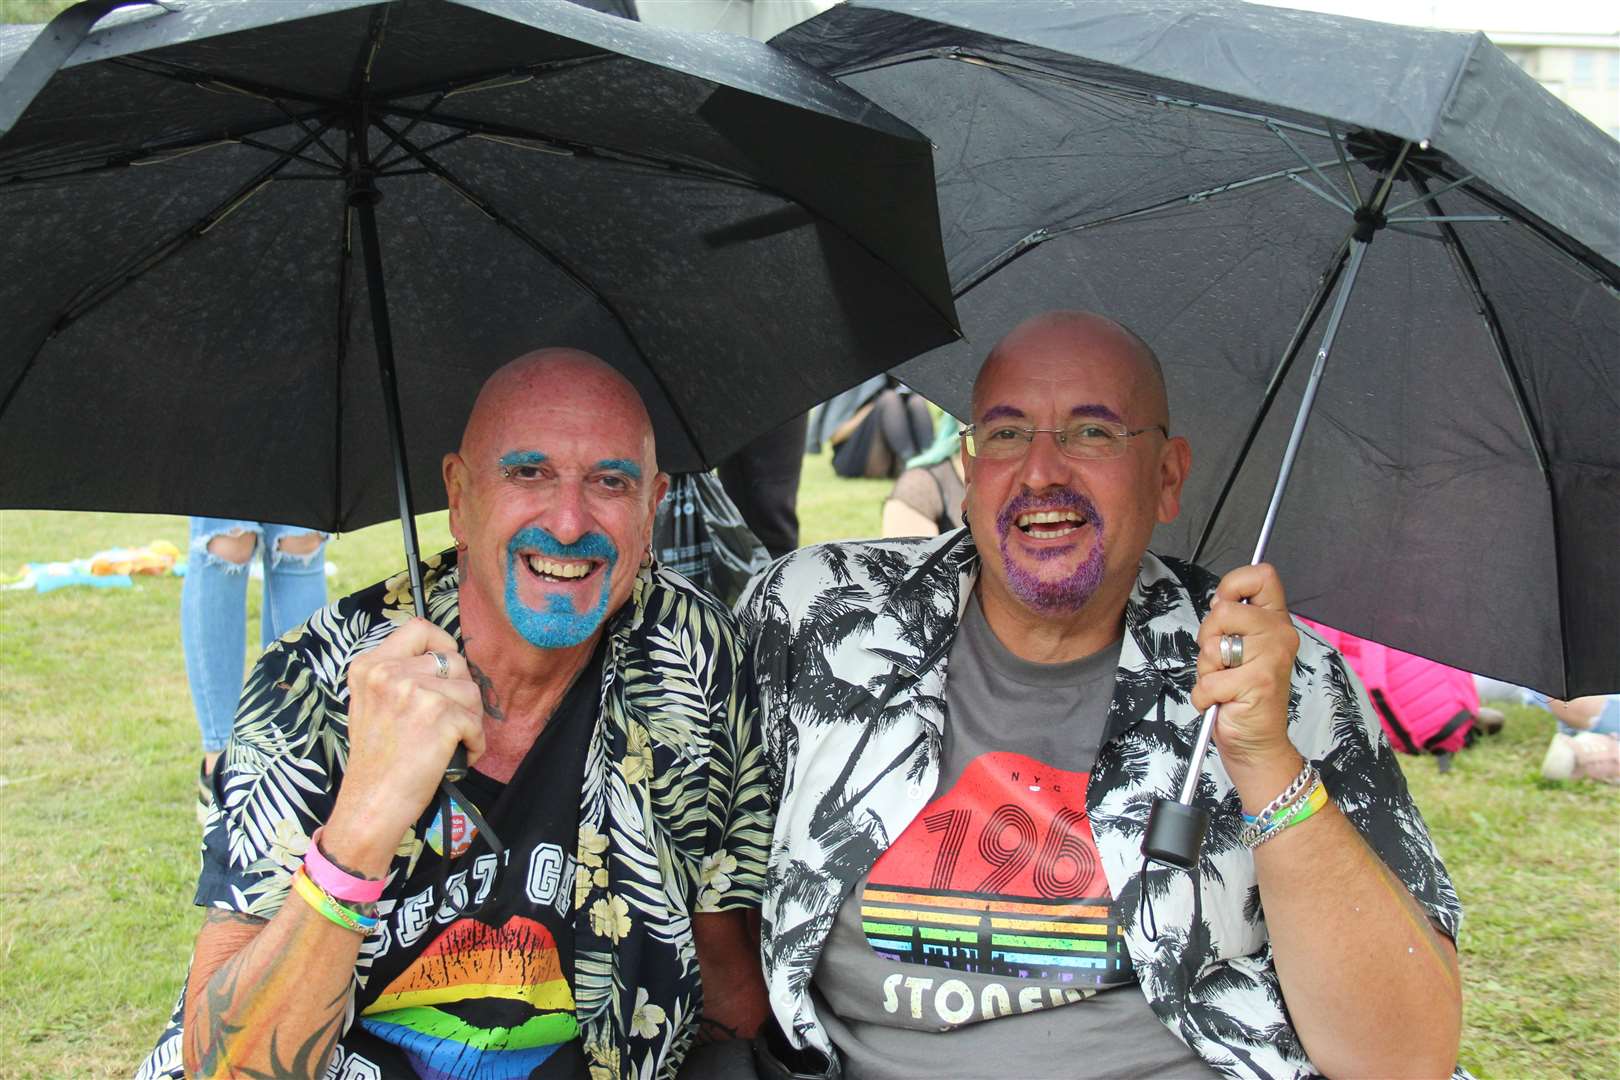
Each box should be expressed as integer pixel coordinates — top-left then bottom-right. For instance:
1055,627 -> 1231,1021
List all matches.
180,518 -> 326,753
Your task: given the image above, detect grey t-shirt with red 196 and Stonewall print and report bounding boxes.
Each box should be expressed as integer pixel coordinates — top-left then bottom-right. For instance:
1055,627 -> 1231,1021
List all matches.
812,597 -> 1212,1080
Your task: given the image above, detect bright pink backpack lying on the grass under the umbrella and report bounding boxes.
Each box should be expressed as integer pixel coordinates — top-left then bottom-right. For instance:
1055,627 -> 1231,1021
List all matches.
1299,619 -> 1479,755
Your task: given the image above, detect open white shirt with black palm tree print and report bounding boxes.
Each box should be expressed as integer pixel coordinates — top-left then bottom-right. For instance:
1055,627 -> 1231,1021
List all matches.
737,529 -> 1466,1077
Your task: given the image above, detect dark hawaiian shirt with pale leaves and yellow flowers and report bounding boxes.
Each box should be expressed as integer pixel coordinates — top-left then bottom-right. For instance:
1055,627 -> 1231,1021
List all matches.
139,552 -> 773,1080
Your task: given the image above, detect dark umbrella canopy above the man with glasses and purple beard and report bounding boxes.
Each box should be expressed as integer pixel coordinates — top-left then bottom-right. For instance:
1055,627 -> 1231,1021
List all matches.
773,0 -> 1620,695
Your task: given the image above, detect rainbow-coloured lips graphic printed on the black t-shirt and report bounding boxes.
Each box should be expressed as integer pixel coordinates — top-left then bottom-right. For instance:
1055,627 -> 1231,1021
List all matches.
360,916 -> 580,1080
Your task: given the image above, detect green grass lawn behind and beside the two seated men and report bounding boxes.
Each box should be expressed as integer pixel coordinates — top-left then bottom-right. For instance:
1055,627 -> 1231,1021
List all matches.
0,455 -> 1620,1078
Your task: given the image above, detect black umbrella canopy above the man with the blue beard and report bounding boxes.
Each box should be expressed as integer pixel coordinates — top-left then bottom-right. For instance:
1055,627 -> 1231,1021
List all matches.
0,0 -> 954,529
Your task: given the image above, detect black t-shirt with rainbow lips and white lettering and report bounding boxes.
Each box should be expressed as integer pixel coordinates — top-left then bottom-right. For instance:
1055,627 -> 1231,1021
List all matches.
341,648 -> 603,1080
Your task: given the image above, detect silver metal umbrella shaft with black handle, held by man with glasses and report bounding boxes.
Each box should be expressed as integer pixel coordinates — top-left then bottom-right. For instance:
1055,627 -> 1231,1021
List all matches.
1142,236 -> 1369,870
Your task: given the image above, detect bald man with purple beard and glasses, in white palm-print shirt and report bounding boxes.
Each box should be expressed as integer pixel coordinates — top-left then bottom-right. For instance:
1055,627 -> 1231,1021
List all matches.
737,311 -> 1461,1080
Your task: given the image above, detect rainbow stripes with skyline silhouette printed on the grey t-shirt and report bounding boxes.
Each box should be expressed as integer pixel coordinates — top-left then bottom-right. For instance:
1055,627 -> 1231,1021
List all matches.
860,884 -> 1131,988
